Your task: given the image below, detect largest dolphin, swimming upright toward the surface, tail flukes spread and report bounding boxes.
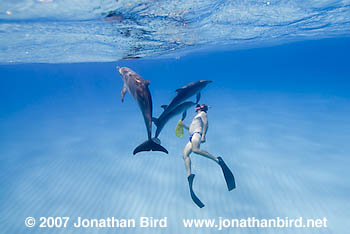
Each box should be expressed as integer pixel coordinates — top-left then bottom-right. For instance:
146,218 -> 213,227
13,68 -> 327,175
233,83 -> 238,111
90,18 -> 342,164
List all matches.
117,66 -> 168,155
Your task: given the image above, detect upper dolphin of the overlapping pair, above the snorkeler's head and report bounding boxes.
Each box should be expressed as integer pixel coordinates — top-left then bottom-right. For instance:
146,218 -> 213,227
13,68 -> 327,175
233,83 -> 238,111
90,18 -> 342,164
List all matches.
159,80 -> 212,118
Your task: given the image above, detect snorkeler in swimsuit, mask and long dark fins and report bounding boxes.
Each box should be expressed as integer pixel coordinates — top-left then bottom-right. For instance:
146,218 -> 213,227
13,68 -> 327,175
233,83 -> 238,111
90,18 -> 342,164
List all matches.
181,104 -> 236,208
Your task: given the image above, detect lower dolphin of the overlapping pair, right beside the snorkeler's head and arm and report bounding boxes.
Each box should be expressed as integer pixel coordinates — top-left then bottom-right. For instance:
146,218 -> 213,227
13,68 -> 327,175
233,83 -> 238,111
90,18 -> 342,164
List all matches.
152,102 -> 197,138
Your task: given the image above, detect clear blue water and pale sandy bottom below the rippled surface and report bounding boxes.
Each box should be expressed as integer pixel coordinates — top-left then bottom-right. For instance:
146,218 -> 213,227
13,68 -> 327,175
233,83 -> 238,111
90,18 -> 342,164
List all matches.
0,38 -> 350,234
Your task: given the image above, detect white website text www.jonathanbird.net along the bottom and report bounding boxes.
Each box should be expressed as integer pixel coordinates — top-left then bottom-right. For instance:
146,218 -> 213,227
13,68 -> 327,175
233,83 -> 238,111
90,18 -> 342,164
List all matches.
182,217 -> 327,230
